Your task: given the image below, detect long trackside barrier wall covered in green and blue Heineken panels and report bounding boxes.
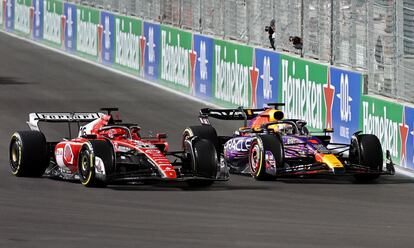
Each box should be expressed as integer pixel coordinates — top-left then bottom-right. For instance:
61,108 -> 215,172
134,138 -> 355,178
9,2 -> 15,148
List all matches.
0,0 -> 414,170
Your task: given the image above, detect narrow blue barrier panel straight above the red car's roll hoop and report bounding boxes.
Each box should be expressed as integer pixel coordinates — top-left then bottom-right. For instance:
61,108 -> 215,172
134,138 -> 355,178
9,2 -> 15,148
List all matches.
98,11 -> 115,64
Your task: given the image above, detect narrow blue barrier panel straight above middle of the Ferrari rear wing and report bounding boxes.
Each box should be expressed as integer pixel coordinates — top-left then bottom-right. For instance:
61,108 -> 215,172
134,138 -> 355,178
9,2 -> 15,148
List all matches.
64,3 -> 77,52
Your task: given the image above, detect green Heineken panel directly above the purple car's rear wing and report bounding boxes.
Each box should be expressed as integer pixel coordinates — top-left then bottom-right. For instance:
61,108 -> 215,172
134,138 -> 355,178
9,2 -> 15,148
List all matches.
212,40 -> 253,108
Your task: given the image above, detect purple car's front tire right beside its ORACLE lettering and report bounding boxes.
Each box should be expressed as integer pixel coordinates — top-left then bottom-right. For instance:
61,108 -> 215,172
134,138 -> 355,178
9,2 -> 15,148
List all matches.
249,134 -> 284,180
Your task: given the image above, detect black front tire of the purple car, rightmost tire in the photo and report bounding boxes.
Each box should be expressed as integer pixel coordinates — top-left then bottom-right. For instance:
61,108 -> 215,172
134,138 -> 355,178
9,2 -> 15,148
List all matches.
349,134 -> 384,182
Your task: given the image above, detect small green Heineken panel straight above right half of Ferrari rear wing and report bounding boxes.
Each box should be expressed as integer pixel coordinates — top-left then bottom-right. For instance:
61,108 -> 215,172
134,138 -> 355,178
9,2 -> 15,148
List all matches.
76,5 -> 99,60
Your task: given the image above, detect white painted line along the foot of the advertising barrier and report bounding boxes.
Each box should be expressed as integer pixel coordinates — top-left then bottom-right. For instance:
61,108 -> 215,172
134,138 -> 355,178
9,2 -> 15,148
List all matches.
0,29 -> 414,178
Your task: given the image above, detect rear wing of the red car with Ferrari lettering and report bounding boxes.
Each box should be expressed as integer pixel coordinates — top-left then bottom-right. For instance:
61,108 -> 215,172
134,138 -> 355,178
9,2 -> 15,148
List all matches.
27,112 -> 104,131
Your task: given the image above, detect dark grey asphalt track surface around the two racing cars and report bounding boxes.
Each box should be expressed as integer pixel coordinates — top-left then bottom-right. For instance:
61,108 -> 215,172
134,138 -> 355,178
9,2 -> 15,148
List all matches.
0,34 -> 414,248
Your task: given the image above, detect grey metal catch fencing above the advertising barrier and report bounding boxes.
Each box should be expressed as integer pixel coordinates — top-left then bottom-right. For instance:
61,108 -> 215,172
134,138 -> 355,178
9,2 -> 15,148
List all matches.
71,0 -> 414,102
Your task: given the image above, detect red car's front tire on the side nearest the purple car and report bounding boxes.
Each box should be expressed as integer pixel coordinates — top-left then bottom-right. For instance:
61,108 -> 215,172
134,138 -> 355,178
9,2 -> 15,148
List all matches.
187,139 -> 218,187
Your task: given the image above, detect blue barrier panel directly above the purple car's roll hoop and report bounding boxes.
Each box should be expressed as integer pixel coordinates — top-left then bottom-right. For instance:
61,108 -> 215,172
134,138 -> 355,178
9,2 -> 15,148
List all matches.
252,49 -> 279,108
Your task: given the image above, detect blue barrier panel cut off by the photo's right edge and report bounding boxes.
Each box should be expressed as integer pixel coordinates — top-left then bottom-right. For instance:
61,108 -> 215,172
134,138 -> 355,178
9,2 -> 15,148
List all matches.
400,106 -> 414,170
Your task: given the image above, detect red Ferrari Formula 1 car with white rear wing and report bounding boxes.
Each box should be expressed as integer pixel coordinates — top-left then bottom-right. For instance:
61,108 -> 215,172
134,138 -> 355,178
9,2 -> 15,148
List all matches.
10,108 -> 228,187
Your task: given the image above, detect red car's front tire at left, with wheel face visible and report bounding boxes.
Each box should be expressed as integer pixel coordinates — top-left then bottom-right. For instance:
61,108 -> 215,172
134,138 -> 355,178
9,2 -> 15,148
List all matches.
78,140 -> 115,187
